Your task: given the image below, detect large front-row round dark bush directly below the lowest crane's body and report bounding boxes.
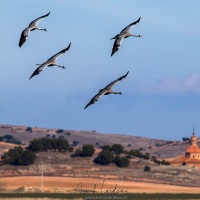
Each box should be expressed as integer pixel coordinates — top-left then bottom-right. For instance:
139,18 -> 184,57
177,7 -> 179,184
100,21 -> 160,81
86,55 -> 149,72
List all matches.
94,150 -> 113,165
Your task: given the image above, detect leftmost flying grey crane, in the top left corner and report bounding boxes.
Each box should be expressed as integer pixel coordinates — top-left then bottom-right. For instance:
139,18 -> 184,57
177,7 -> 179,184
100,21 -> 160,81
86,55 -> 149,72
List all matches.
19,12 -> 50,47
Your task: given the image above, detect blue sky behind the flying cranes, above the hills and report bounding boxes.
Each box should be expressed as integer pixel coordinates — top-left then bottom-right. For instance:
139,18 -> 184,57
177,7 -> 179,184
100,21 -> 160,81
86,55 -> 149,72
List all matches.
0,0 -> 200,140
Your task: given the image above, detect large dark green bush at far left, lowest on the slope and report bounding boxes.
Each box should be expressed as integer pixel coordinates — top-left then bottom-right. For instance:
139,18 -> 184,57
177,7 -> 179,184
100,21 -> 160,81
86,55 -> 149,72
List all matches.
2,146 -> 36,165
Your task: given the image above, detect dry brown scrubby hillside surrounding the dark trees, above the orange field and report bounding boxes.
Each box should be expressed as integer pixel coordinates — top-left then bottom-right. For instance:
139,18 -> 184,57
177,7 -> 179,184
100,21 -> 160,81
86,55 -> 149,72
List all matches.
0,122 -> 200,191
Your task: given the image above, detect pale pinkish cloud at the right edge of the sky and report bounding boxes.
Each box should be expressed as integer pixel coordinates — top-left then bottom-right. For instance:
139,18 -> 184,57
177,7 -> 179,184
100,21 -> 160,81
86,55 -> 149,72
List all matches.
134,72 -> 200,95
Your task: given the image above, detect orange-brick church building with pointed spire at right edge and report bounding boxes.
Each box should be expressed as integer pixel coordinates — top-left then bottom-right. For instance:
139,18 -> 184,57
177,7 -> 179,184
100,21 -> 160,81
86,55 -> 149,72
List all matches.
170,129 -> 200,168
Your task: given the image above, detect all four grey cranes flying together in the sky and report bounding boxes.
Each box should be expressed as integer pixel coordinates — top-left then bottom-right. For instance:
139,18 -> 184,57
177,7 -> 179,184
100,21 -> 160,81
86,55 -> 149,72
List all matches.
19,12 -> 142,109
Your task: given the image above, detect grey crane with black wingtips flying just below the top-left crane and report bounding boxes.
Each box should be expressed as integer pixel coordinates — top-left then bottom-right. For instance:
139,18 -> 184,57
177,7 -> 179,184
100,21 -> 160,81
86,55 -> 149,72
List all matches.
29,42 -> 71,80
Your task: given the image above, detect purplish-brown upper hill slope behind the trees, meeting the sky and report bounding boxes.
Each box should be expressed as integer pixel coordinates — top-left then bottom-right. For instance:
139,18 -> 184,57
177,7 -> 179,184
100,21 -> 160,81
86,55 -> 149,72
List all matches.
0,124 -> 191,159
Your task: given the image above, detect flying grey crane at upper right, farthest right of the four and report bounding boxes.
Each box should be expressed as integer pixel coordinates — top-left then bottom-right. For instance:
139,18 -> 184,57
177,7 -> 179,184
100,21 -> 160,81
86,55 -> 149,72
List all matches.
111,17 -> 142,56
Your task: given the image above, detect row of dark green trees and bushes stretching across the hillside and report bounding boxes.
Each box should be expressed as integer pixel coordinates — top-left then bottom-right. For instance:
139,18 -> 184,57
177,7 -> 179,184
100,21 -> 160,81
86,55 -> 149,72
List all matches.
2,137 -> 169,167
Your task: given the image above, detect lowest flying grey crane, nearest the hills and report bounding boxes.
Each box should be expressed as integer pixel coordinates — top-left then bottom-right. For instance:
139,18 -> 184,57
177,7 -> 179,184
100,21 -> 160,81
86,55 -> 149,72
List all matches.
84,71 -> 129,109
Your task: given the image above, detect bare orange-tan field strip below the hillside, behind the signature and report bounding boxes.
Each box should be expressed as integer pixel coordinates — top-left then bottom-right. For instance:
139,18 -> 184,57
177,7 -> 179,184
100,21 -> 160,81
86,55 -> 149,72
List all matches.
0,176 -> 199,193
